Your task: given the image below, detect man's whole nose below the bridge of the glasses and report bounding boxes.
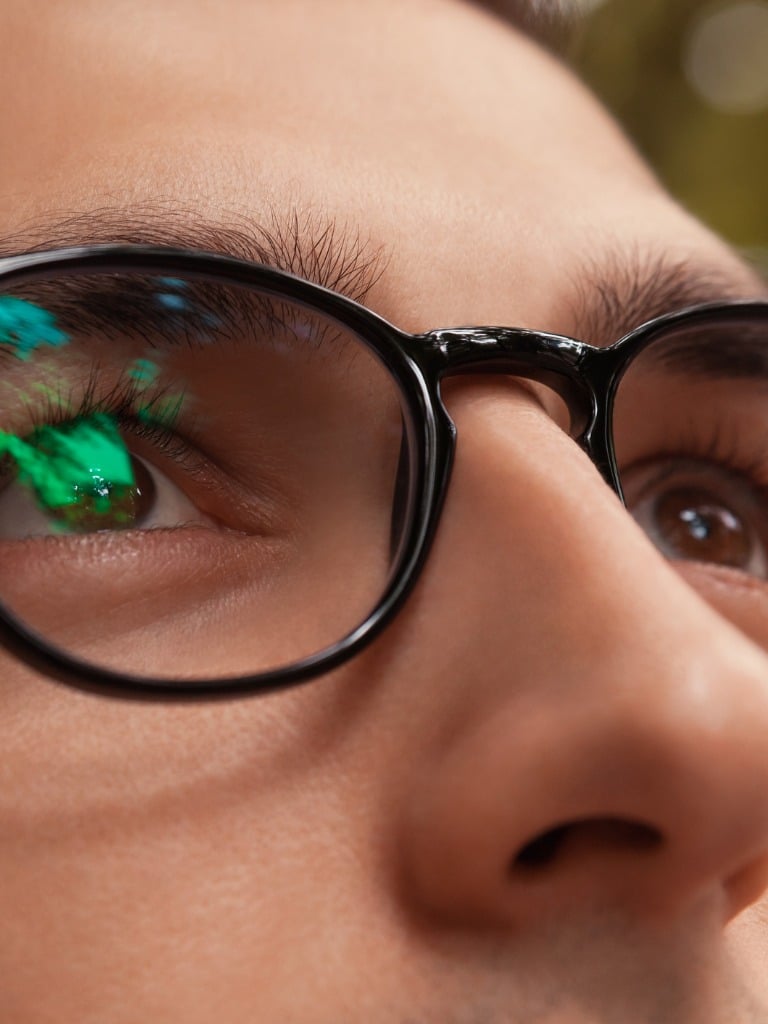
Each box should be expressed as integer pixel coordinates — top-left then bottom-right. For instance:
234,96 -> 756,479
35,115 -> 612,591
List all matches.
402,381 -> 768,927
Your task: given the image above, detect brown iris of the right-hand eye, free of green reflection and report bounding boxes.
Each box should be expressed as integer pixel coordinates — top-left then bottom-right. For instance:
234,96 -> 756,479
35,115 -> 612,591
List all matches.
654,487 -> 753,569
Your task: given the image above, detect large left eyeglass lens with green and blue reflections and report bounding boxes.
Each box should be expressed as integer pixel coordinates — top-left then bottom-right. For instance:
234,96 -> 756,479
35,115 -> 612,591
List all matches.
0,272 -> 409,680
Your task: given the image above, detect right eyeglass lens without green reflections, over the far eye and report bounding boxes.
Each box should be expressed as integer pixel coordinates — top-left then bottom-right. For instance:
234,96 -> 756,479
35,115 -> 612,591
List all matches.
613,315 -> 768,580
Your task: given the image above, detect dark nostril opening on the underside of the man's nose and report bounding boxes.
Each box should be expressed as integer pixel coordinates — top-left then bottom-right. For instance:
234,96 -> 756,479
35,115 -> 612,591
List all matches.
512,818 -> 664,871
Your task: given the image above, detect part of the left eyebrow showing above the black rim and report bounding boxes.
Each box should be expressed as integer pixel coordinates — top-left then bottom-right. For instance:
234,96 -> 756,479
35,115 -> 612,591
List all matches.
0,199 -> 387,302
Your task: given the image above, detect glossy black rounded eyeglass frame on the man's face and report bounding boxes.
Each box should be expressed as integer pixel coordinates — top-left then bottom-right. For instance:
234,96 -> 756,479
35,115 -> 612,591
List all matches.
0,245 -> 768,700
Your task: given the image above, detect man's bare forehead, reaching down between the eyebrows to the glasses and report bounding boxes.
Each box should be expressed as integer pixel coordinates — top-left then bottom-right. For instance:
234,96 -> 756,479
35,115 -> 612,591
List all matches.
0,0 -> 761,329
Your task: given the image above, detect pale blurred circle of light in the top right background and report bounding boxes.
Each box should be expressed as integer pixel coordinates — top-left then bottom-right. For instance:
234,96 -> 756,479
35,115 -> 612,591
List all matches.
683,0 -> 768,114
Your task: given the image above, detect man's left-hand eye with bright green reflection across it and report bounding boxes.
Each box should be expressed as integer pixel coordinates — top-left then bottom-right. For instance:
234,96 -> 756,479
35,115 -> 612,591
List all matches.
0,416 -> 211,540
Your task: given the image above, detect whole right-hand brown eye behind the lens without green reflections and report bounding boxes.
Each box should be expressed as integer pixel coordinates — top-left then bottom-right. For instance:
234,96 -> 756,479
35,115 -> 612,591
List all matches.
623,460 -> 768,579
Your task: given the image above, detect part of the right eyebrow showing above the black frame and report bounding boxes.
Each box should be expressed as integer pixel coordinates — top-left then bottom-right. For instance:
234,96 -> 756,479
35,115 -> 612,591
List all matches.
568,245 -> 768,346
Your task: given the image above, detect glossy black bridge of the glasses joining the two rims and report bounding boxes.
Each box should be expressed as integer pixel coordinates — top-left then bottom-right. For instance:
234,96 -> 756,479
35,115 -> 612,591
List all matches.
425,327 -> 598,438
